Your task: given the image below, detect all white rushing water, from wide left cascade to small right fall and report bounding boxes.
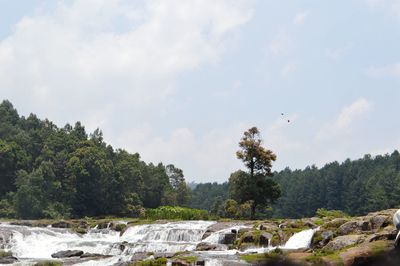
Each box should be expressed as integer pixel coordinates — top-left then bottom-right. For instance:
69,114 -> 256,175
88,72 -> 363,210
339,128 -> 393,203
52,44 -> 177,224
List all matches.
0,221 -> 318,266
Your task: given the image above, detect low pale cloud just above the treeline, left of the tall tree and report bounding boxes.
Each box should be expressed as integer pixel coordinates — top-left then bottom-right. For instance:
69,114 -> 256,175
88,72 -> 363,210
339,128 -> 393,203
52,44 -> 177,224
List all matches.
117,124 -> 248,182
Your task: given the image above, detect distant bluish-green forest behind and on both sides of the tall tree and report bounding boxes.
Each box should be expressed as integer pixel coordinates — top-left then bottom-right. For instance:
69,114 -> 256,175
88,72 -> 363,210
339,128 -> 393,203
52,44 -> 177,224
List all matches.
191,151 -> 400,218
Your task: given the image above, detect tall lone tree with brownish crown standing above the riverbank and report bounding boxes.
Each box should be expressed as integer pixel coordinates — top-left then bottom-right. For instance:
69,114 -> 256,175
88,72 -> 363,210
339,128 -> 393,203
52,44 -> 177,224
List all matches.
229,127 -> 281,219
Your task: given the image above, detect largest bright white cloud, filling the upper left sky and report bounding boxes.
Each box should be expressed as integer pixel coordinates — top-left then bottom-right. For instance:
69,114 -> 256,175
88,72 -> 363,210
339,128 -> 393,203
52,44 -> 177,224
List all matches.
0,0 -> 252,127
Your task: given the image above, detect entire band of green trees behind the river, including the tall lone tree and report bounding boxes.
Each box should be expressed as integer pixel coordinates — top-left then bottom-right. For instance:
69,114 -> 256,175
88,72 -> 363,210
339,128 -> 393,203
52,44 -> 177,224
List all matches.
0,98 -> 400,219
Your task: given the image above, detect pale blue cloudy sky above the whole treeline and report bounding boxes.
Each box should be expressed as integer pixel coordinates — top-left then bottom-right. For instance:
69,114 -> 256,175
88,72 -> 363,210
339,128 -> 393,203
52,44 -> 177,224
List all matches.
0,0 -> 400,182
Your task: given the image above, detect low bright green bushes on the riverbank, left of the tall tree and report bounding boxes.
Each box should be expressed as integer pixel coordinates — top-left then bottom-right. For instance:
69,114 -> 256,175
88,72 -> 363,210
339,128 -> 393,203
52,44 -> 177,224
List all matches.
143,206 -> 209,220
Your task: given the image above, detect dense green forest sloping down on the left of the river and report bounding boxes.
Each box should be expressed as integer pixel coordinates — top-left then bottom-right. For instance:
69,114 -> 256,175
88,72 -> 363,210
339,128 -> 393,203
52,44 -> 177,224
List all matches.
0,101 -> 190,218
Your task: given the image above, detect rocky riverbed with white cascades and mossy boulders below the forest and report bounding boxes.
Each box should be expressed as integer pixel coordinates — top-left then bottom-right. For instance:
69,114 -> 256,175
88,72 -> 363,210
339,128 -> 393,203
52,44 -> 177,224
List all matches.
0,209 -> 400,265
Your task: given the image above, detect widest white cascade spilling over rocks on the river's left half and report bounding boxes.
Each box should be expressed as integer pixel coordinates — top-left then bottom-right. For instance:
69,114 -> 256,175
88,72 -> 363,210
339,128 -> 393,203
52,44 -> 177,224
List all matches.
0,221 -> 215,265
